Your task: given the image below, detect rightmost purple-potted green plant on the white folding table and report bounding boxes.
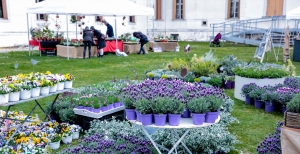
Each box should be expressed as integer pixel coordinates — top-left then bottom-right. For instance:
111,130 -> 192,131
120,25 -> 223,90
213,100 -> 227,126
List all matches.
205,96 -> 224,123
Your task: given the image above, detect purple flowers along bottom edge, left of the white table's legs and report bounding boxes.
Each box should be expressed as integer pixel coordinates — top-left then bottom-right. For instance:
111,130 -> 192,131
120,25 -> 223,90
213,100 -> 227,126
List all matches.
62,134 -> 154,154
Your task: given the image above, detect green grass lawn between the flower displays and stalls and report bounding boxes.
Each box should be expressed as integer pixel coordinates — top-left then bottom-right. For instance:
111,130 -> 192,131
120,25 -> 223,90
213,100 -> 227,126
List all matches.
0,42 -> 300,153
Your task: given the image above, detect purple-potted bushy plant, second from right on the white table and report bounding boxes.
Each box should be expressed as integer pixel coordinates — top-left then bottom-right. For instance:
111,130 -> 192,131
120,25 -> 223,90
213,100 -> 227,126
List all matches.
187,97 -> 209,125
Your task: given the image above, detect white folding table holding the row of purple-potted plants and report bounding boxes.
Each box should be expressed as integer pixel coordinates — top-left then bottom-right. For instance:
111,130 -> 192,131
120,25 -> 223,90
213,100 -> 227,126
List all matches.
130,116 -> 220,154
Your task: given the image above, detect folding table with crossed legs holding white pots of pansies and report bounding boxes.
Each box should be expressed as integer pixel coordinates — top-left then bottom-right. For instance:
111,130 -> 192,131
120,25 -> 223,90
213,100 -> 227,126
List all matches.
0,88 -> 73,144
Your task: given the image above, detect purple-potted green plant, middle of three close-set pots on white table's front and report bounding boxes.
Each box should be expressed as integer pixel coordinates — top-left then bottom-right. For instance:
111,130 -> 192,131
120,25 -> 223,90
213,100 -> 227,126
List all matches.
151,97 -> 168,126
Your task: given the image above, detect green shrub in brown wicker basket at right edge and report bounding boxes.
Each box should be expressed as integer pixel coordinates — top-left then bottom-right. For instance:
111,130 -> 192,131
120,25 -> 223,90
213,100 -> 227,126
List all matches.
284,94 -> 300,129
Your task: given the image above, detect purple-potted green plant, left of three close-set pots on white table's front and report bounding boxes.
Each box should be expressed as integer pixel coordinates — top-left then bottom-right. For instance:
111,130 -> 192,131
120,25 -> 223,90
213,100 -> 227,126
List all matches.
135,98 -> 153,125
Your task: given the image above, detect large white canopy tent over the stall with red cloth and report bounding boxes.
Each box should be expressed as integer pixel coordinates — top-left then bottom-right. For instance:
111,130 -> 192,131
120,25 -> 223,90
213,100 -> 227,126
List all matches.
26,0 -> 154,60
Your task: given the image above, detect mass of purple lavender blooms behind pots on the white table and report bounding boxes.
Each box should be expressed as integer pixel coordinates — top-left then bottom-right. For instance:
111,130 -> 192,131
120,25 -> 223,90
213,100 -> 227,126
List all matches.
120,79 -> 225,103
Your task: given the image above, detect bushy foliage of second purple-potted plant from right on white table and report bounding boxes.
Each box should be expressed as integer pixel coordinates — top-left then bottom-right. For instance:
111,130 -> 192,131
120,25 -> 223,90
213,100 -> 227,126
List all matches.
187,97 -> 210,114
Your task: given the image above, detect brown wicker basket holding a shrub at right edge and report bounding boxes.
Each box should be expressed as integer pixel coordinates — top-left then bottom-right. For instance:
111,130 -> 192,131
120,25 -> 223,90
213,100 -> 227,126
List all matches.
284,111 -> 300,129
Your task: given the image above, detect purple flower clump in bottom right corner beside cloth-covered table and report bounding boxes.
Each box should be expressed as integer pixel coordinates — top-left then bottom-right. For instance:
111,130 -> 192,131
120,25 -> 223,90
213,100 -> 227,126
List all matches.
256,122 -> 283,154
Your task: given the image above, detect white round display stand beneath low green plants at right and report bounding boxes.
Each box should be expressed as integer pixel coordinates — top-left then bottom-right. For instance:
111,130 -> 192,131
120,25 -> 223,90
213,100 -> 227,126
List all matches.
234,75 -> 285,101
